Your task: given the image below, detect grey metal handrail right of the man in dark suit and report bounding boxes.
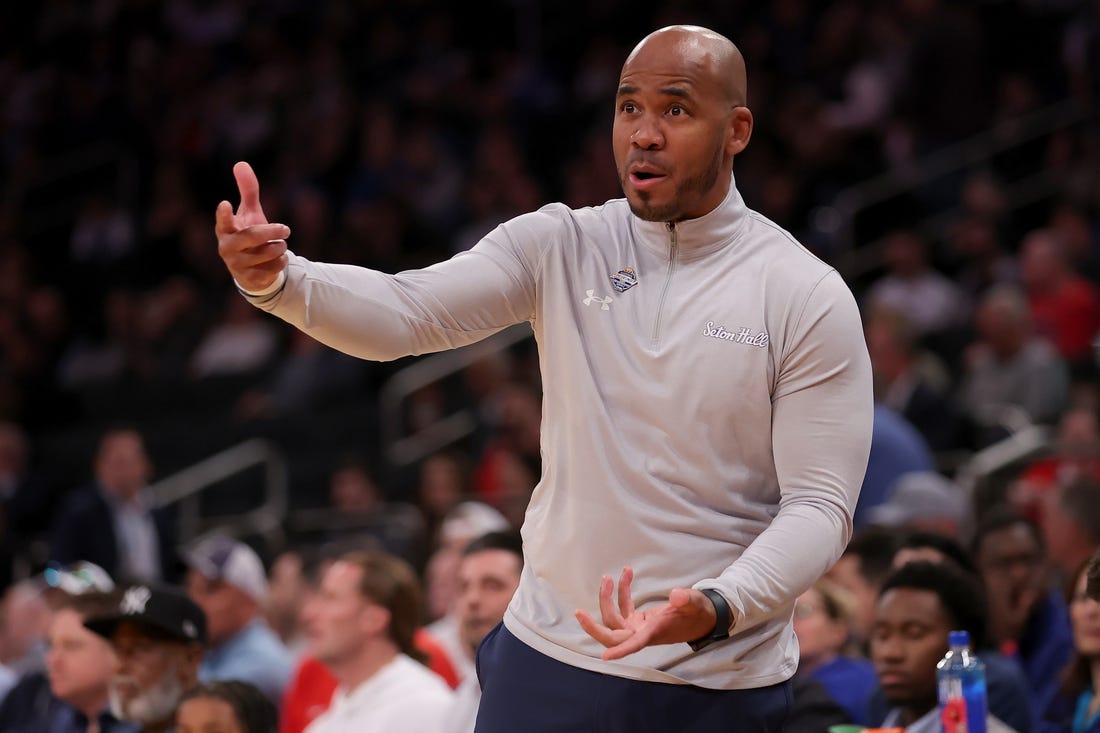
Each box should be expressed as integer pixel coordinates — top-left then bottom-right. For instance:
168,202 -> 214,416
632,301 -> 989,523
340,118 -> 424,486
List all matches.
151,438 -> 289,548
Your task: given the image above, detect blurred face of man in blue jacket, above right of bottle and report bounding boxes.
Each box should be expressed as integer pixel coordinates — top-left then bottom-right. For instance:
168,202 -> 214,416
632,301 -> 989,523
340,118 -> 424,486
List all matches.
975,523 -> 1046,620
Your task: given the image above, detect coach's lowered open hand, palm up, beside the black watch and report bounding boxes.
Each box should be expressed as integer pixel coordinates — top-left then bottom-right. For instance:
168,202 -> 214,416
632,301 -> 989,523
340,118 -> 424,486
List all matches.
574,568 -> 717,659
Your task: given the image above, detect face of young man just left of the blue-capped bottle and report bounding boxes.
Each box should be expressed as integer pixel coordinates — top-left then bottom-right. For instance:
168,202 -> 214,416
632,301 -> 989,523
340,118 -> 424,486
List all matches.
870,588 -> 952,714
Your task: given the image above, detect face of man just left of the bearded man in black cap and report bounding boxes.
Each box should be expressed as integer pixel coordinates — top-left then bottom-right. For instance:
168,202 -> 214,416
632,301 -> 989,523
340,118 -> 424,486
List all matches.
46,609 -> 119,714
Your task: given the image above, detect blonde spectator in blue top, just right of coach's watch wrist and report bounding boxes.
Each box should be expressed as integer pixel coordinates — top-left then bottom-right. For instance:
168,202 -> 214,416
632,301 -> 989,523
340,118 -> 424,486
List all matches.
794,579 -> 877,725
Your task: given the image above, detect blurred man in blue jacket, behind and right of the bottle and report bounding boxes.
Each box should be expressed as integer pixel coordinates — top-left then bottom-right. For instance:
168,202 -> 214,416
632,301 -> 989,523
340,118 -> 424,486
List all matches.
971,506 -> 1073,726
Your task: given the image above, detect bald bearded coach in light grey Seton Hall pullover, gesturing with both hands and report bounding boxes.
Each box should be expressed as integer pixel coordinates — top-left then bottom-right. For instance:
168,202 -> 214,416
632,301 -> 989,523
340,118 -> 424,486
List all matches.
216,26 -> 872,733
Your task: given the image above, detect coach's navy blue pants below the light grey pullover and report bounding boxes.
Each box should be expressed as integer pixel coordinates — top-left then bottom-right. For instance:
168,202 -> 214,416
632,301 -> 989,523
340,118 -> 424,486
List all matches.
475,624 -> 792,733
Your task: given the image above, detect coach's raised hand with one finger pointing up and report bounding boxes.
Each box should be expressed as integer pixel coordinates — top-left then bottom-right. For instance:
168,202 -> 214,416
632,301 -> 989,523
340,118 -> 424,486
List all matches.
213,162 -> 290,293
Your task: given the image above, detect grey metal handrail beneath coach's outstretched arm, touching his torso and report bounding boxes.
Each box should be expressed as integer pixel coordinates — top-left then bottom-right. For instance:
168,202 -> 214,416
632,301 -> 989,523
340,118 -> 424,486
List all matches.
380,324 -> 531,468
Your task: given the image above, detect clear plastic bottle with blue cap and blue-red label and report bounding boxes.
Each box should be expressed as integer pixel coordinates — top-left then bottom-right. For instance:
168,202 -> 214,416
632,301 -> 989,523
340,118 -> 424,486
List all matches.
936,631 -> 988,733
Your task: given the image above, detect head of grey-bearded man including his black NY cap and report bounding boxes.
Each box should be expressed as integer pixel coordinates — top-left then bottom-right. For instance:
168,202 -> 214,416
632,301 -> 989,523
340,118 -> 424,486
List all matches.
84,586 -> 206,733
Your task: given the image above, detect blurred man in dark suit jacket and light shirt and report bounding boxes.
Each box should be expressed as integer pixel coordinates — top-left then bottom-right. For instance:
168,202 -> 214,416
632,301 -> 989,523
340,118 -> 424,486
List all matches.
50,428 -> 179,581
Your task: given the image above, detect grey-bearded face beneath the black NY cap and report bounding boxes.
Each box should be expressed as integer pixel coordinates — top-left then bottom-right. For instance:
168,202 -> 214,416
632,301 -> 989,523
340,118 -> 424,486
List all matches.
110,623 -> 201,726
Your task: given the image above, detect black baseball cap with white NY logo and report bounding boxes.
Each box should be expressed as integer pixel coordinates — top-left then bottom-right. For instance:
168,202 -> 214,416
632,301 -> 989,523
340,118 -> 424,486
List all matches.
84,584 -> 206,644
